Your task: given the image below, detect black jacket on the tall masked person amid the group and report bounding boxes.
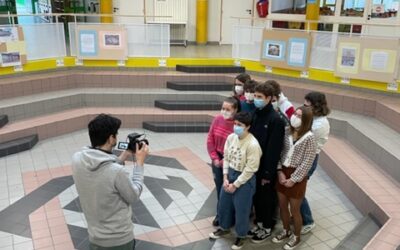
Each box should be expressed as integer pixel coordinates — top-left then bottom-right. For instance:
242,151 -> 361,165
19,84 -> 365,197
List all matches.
250,103 -> 285,182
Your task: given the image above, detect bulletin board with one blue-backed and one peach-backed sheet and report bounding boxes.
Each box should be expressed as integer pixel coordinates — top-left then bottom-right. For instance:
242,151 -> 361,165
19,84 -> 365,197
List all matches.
76,24 -> 128,60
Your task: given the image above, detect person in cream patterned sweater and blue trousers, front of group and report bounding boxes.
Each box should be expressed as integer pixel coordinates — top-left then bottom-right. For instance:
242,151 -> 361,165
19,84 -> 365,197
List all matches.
210,112 -> 262,249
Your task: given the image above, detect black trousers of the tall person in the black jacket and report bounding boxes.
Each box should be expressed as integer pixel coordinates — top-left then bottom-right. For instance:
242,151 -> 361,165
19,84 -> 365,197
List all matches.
253,177 -> 278,229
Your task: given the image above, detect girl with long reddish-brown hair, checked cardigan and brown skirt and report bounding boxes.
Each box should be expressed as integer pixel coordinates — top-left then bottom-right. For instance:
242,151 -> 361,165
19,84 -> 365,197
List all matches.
272,106 -> 317,250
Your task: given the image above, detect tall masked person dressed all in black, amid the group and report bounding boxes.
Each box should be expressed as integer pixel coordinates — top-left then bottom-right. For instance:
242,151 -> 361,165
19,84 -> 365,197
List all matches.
248,81 -> 285,243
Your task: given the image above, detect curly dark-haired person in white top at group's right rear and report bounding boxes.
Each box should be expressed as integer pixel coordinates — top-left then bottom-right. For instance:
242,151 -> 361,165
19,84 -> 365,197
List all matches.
300,92 -> 330,234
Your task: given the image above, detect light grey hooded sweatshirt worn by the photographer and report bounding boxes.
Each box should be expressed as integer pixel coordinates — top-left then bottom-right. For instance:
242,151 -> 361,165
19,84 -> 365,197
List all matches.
72,147 -> 143,247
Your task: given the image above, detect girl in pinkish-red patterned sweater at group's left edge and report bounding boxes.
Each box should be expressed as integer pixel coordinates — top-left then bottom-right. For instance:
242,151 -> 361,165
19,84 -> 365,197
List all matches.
207,97 -> 240,226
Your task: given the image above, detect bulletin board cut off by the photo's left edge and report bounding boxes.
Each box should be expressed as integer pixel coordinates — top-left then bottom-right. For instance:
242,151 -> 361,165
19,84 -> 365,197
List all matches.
0,26 -> 27,67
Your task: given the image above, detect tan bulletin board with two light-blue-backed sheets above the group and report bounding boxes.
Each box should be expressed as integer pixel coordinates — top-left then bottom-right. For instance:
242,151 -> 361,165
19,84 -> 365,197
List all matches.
260,29 -> 311,71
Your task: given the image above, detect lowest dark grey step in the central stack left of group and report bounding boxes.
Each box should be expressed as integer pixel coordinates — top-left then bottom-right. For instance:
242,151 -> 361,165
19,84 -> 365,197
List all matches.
143,122 -> 210,133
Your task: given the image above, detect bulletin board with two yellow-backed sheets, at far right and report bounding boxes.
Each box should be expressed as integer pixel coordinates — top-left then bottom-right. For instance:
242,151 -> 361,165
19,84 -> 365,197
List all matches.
335,37 -> 399,82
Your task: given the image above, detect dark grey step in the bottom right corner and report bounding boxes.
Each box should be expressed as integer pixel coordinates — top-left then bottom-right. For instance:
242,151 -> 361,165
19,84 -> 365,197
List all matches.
335,215 -> 382,250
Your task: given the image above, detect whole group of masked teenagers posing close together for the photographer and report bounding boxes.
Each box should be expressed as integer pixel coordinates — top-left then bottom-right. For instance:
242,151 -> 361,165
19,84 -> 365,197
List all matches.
207,73 -> 330,249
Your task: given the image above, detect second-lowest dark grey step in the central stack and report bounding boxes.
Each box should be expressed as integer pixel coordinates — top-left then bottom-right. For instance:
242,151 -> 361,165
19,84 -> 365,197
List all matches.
154,100 -> 222,110
